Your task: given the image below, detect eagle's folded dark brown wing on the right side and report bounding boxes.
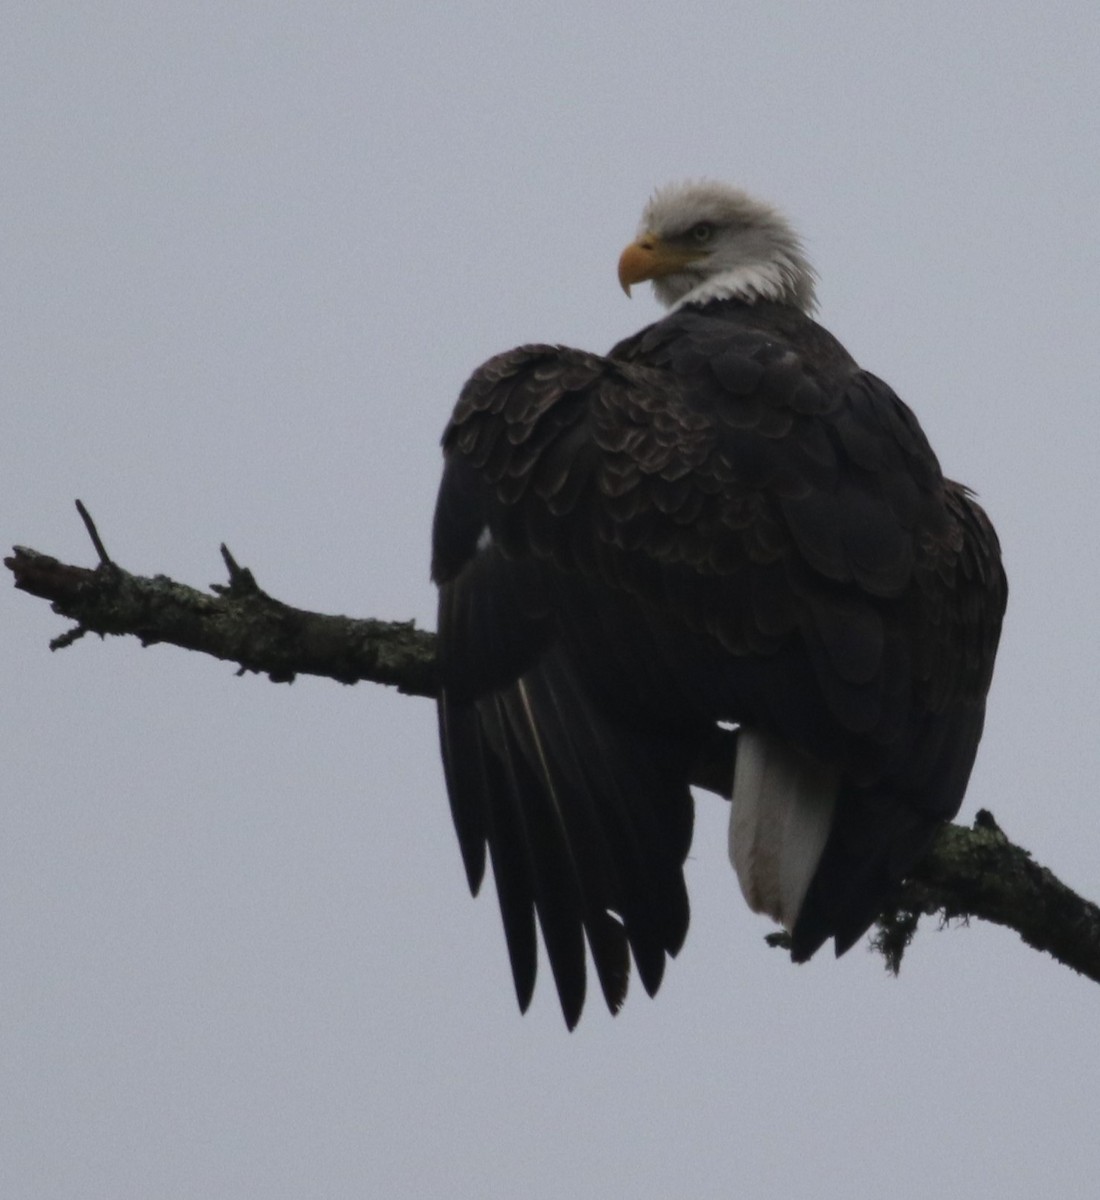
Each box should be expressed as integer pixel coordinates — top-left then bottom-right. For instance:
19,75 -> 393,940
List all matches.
792,480 -> 1008,961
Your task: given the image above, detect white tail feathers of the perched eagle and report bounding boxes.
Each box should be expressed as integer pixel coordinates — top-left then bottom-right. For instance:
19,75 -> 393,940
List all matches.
729,727 -> 838,929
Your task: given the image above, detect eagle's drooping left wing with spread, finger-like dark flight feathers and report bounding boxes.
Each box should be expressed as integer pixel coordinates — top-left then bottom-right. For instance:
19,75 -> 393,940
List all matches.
433,348 -> 697,1026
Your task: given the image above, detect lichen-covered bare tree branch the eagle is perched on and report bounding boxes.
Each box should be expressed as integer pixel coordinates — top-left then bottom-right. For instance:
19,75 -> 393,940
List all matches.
4,535 -> 1100,983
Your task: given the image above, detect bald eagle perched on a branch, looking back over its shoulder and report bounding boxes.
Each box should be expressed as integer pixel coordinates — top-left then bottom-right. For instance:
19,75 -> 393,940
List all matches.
432,182 -> 1006,1028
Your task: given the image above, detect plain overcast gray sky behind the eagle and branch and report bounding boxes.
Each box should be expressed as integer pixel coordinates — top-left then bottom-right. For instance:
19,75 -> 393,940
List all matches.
0,0 -> 1100,1200
